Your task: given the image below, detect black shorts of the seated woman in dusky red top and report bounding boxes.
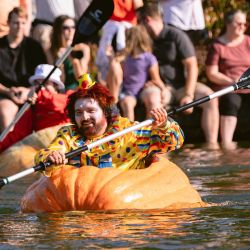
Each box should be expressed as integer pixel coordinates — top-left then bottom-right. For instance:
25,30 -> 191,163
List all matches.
219,93 -> 241,116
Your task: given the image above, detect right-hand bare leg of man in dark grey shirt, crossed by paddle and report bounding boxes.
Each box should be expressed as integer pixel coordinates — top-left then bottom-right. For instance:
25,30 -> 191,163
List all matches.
195,83 -> 219,144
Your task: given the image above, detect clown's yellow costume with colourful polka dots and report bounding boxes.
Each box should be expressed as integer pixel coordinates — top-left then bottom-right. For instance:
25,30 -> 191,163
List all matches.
35,116 -> 184,174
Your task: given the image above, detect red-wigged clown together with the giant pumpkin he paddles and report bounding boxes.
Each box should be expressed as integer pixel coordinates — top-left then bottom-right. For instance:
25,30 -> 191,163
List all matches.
18,74 -> 205,212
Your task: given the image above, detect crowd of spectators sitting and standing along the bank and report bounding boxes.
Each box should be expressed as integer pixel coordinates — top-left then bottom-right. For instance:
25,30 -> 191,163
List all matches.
0,0 -> 250,149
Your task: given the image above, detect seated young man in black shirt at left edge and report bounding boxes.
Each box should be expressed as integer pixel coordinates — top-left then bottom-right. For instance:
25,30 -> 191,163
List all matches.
0,7 -> 47,132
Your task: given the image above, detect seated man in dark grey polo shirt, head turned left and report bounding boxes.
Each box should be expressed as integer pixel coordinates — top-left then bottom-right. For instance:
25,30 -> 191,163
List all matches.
137,4 -> 219,147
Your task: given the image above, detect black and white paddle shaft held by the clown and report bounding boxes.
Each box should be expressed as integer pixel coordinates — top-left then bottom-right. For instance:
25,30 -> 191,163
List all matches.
0,69 -> 250,189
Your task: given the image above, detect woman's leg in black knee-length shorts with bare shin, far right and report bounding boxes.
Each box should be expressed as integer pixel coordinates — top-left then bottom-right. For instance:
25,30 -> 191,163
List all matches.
219,93 -> 241,148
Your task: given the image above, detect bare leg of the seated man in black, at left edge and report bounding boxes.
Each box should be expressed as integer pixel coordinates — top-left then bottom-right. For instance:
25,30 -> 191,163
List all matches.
0,98 -> 18,133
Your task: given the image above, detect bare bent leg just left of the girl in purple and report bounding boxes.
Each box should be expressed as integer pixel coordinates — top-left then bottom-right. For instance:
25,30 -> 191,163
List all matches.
107,59 -> 123,103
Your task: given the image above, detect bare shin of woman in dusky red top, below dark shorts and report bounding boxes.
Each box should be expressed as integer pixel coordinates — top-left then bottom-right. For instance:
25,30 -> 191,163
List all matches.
220,116 -> 237,147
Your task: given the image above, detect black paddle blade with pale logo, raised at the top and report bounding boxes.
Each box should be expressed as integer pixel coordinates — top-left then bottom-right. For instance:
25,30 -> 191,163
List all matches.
71,0 -> 114,47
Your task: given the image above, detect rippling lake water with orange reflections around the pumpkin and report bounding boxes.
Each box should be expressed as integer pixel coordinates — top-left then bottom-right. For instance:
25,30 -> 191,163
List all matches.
0,145 -> 250,249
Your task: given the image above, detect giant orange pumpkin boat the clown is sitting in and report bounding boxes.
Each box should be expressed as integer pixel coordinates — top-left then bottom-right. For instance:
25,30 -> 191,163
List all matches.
21,157 -> 205,212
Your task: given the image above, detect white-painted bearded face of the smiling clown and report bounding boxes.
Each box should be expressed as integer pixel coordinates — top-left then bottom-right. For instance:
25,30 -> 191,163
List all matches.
75,98 -> 107,138
